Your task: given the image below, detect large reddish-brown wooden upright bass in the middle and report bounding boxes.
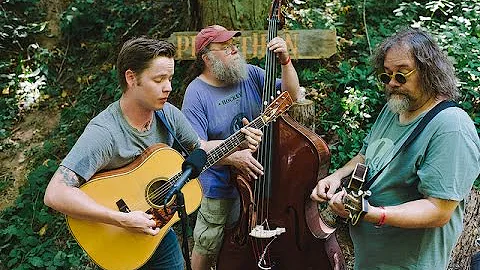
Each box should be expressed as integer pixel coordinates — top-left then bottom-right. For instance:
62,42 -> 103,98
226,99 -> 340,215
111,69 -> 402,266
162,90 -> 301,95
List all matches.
217,0 -> 344,270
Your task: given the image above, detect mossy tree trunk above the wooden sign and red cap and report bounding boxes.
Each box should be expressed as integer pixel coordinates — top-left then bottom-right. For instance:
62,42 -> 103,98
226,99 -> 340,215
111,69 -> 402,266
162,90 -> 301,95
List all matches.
195,0 -> 271,30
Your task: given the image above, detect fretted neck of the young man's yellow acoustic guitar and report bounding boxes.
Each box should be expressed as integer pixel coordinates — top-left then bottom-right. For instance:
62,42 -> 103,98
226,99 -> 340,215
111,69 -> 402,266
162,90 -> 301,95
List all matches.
202,115 -> 267,172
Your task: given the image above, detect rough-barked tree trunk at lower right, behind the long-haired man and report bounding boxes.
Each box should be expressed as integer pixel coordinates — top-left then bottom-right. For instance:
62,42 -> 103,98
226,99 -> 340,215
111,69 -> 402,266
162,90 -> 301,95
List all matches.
447,188 -> 480,270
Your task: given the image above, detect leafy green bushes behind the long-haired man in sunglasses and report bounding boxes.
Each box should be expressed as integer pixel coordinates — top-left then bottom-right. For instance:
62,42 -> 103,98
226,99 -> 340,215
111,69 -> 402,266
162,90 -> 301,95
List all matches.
289,0 -> 480,170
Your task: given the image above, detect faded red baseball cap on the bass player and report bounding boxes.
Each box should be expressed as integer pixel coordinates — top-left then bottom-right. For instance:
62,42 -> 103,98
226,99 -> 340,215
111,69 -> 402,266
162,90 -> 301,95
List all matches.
195,25 -> 242,54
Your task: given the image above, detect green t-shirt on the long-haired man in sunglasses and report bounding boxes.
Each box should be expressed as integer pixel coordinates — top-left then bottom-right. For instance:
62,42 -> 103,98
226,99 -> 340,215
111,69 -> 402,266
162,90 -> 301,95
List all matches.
350,106 -> 480,270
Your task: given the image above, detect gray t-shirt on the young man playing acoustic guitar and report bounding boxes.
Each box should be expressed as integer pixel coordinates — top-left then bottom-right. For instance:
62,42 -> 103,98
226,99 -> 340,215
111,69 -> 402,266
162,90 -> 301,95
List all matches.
60,101 -> 200,181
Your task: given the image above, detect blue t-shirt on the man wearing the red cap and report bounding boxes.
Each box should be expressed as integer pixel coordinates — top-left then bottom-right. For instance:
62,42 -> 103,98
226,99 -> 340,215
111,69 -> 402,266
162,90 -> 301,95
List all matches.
182,65 -> 280,199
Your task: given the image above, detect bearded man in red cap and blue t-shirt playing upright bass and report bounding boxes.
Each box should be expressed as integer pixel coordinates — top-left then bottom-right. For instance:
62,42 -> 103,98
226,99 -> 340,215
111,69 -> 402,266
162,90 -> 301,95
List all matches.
182,25 -> 300,270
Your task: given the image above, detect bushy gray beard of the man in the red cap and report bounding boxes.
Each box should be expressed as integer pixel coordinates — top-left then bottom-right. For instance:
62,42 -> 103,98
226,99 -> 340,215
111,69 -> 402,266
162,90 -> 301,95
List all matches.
207,52 -> 248,85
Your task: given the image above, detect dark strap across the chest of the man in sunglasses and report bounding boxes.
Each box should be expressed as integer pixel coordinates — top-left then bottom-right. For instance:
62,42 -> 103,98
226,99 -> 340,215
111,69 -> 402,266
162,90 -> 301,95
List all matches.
362,100 -> 458,191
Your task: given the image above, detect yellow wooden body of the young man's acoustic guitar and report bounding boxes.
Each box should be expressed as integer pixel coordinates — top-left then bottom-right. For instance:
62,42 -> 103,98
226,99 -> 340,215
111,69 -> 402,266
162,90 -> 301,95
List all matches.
67,144 -> 202,269
